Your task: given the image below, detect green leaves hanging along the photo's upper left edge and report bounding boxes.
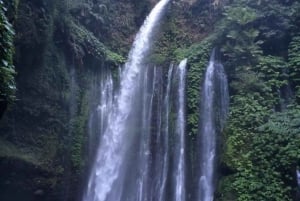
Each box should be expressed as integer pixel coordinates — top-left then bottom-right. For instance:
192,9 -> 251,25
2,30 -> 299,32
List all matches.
0,1 -> 16,102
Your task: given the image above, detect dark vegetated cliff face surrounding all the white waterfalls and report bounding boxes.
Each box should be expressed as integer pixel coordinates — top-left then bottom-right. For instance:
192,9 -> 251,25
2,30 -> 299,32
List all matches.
0,0 -> 300,201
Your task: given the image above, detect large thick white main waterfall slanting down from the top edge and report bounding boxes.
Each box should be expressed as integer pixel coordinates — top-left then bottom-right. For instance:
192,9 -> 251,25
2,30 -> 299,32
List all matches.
83,0 -> 169,201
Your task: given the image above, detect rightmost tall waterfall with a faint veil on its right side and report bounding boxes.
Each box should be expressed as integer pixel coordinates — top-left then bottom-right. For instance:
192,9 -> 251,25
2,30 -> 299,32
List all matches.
198,51 -> 229,201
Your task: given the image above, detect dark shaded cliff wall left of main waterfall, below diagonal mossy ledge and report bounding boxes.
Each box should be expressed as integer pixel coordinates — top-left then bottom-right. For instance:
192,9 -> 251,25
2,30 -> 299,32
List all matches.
0,0 -> 122,201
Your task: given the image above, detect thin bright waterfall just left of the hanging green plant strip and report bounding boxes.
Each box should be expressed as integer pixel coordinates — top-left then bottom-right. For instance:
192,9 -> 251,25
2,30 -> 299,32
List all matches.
175,59 -> 187,201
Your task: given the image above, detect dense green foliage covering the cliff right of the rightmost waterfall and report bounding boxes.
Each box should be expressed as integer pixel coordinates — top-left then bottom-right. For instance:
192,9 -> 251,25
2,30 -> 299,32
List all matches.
215,0 -> 300,201
